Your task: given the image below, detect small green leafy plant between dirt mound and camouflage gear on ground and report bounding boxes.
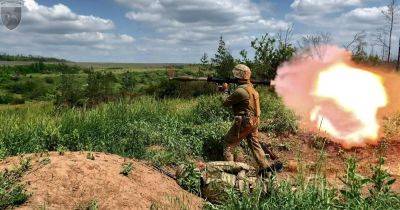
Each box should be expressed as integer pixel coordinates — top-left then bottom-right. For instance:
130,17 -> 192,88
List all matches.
177,163 -> 201,195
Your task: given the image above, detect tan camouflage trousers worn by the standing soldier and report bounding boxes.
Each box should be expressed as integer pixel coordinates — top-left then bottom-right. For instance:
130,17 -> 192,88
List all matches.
224,116 -> 269,168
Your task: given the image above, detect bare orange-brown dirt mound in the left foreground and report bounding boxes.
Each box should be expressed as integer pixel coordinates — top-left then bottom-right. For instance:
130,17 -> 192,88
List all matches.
0,152 -> 202,209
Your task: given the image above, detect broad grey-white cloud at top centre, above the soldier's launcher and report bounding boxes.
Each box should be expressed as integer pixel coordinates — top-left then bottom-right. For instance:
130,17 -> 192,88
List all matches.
115,0 -> 289,43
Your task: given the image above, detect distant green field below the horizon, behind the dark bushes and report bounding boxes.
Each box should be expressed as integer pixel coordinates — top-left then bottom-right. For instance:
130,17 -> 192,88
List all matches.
0,61 -> 208,104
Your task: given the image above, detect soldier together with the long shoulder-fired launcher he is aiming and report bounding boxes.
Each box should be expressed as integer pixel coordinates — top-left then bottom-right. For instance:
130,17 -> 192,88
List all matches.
168,64 -> 283,175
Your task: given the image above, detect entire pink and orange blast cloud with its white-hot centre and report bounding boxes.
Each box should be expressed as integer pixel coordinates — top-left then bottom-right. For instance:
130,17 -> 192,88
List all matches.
274,45 -> 400,148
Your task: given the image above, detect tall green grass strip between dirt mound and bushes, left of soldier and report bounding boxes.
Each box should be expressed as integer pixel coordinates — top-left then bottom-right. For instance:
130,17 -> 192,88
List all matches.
0,90 -> 295,165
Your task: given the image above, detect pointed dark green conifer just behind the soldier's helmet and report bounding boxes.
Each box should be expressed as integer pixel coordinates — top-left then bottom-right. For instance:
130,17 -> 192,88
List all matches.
211,36 -> 236,78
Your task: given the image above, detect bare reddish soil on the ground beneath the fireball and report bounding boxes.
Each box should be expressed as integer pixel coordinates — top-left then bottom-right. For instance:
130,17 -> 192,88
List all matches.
261,133 -> 400,192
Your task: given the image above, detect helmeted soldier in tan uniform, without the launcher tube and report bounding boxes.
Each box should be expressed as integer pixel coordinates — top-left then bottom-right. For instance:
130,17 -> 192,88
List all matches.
223,64 -> 283,175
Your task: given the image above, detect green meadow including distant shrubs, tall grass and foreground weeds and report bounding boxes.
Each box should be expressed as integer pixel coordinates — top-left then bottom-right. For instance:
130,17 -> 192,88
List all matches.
0,51 -> 400,209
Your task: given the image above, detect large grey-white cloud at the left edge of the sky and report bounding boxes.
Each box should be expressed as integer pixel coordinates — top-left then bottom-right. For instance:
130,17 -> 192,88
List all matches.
0,0 -> 135,60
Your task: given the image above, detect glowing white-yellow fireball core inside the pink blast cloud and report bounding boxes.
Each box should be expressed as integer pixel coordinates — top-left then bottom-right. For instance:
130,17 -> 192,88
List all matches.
310,62 -> 388,147
